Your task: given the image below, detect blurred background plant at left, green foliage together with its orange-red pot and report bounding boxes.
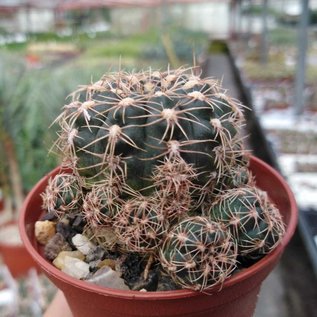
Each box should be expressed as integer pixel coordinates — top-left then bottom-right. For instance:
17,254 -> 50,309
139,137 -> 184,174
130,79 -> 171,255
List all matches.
0,52 -> 102,277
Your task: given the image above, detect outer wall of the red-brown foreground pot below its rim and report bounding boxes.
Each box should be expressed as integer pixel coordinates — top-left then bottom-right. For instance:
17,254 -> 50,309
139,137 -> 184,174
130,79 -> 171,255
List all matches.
50,268 -> 266,317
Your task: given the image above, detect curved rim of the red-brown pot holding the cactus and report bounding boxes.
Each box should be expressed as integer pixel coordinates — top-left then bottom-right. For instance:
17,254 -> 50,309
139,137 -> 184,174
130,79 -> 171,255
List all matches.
19,155 -> 297,300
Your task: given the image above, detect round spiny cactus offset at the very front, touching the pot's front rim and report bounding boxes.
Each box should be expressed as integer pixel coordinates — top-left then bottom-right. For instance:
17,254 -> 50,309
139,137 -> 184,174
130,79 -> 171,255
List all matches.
160,216 -> 237,291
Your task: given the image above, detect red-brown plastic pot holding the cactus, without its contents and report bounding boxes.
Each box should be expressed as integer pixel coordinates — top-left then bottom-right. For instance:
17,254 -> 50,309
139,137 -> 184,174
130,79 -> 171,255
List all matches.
20,157 -> 297,317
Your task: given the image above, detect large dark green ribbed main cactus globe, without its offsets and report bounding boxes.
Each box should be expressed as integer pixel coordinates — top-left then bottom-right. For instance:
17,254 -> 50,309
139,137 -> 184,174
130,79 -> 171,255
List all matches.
56,69 -> 242,191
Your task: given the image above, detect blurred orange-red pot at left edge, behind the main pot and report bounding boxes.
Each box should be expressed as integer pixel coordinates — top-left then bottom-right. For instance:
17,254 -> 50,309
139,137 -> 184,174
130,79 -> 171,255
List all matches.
0,221 -> 38,278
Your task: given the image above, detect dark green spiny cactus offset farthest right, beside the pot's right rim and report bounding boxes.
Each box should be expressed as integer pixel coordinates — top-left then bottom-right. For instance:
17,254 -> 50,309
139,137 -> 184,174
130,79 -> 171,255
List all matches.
209,186 -> 284,258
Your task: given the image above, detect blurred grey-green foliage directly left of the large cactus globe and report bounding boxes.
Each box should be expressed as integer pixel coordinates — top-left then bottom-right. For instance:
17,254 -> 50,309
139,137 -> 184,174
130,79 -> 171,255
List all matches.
10,66 -> 100,191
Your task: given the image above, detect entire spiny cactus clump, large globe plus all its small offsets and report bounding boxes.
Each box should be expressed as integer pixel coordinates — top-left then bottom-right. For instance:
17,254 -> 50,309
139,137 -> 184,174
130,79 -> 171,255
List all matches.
38,68 -> 283,291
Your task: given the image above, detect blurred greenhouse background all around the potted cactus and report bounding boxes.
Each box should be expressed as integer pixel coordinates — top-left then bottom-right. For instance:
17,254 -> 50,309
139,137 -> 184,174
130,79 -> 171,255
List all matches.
0,0 -> 317,317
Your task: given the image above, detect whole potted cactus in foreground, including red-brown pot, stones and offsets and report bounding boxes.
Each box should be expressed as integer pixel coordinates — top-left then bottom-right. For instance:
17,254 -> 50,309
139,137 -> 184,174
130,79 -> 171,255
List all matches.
20,68 -> 297,317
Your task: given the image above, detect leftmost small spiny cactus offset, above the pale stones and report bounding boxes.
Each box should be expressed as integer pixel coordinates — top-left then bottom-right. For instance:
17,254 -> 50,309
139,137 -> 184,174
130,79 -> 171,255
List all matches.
42,173 -> 82,217
